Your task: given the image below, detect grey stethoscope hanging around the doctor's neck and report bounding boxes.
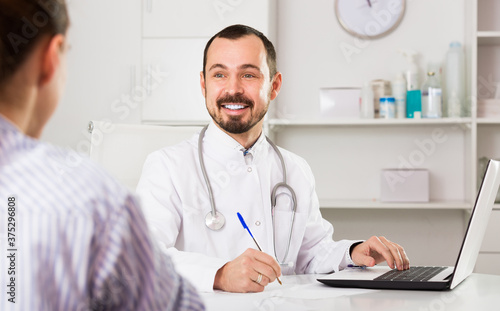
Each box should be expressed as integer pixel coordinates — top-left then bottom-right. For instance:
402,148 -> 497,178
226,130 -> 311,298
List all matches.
198,125 -> 297,264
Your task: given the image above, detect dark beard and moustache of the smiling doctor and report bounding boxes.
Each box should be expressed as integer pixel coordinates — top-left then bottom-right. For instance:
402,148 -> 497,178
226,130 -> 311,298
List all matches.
208,95 -> 267,134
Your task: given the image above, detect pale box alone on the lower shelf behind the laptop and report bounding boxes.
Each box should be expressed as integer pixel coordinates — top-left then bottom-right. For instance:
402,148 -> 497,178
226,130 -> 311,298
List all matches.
380,169 -> 429,202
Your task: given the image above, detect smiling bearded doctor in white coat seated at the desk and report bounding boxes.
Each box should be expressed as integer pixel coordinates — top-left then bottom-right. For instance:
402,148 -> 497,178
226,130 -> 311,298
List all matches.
137,25 -> 409,292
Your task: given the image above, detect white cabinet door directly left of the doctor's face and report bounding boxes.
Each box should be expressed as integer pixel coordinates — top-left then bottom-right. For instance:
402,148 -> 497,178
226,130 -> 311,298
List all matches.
142,38 -> 210,123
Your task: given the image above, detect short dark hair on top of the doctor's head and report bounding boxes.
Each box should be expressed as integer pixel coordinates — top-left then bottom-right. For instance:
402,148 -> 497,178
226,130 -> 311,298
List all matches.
203,25 -> 278,79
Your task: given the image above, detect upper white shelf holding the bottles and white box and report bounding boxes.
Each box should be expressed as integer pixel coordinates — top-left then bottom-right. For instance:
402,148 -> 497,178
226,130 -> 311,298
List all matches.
268,118 -> 472,126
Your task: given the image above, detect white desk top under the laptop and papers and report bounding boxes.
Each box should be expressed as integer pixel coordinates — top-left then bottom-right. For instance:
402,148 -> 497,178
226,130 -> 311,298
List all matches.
201,274 -> 500,311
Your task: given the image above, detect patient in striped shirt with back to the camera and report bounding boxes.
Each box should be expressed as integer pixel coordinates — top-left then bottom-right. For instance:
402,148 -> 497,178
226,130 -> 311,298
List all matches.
0,0 -> 204,311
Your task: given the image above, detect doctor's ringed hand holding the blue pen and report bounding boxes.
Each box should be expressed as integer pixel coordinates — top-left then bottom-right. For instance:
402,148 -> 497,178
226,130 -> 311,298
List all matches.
214,248 -> 281,293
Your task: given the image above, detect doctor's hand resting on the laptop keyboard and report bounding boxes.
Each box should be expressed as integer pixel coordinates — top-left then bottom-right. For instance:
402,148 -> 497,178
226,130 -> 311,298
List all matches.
351,236 -> 410,270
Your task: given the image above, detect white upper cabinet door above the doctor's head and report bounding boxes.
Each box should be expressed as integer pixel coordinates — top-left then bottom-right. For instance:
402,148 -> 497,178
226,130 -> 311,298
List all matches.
143,0 -> 274,38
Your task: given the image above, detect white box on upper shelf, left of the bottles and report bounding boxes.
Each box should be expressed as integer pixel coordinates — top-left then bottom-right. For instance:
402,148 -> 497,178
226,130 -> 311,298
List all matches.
319,87 -> 361,119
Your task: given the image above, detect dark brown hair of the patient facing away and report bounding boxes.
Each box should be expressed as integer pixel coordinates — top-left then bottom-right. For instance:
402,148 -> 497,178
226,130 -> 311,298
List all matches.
0,0 -> 69,86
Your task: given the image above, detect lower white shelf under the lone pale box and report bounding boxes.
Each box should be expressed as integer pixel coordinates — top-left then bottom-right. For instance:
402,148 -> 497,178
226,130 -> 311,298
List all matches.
320,200 -> 470,210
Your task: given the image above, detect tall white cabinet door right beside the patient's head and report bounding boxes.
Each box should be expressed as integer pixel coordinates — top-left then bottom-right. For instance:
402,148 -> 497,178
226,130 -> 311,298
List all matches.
44,0 -> 142,152
